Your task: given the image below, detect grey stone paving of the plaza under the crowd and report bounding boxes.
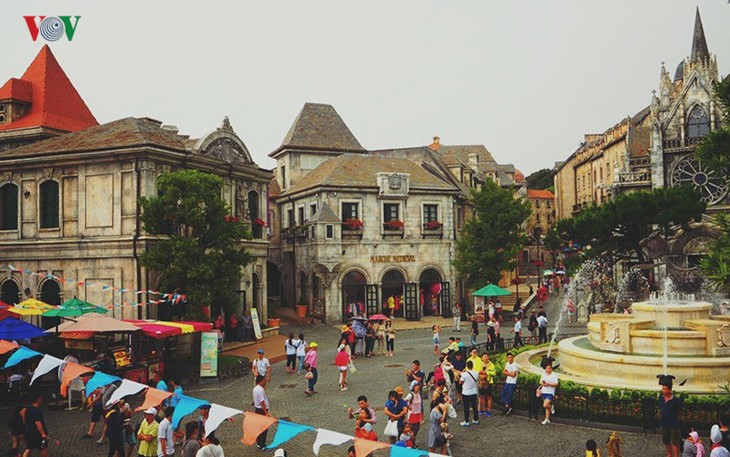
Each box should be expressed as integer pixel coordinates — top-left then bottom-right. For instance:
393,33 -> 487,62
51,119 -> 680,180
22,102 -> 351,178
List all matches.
0,296 -> 664,457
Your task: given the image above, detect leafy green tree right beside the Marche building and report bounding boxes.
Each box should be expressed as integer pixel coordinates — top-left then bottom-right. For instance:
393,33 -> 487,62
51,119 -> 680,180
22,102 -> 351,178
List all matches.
454,180 -> 531,288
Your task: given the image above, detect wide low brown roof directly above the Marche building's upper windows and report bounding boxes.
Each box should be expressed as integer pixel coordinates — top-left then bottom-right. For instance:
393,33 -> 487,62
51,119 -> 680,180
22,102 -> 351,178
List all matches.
281,154 -> 457,195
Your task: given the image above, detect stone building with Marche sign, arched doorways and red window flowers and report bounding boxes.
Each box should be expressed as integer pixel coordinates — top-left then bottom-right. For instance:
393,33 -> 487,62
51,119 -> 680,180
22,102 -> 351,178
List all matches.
269,103 -> 515,322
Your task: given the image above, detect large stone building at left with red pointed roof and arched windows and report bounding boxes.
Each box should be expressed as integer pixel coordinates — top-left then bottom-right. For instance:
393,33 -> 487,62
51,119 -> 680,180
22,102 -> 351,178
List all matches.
0,46 -> 271,318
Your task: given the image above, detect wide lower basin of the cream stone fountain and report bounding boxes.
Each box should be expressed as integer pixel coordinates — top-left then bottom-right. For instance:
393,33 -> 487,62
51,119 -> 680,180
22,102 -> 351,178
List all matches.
515,336 -> 730,394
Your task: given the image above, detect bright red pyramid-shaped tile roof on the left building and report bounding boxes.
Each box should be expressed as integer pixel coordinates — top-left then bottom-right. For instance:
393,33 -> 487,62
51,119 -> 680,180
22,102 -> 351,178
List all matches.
0,45 -> 99,132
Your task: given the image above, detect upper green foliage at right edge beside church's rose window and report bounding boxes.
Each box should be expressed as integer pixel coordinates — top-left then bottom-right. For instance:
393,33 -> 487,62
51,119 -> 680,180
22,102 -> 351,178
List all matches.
696,76 -> 730,177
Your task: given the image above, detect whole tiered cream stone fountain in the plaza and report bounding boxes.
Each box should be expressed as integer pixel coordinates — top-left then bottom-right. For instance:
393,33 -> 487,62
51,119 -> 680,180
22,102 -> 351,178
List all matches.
516,300 -> 730,393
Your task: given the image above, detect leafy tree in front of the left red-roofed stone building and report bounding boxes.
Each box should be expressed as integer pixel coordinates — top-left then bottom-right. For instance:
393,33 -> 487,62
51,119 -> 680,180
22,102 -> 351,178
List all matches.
141,170 -> 251,319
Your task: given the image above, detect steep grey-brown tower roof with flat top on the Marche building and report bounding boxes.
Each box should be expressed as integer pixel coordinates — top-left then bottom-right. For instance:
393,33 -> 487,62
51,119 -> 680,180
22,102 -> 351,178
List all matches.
269,103 -> 366,156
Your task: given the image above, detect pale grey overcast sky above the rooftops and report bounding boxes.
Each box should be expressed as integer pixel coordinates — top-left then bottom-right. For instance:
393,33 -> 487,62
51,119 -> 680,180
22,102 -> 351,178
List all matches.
0,0 -> 730,174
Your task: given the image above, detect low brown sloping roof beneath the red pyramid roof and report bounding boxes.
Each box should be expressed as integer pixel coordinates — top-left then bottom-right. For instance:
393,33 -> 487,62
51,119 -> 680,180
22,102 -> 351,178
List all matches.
0,117 -> 188,160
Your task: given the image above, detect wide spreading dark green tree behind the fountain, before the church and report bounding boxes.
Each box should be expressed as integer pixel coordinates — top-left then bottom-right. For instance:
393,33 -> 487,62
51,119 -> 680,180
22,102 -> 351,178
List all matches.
546,186 -> 706,262
